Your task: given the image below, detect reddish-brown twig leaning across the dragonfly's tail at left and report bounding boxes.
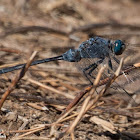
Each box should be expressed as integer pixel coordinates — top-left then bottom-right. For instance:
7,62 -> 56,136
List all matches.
0,51 -> 37,109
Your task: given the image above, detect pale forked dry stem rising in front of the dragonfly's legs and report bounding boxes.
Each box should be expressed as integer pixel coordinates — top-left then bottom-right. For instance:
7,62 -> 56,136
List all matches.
58,59 -> 123,139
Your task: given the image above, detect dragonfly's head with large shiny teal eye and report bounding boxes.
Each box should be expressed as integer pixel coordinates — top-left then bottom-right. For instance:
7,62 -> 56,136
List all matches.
114,40 -> 125,55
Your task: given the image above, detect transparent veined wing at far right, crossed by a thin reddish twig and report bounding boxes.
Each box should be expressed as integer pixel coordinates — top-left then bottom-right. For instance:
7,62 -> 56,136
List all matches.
106,41 -> 140,105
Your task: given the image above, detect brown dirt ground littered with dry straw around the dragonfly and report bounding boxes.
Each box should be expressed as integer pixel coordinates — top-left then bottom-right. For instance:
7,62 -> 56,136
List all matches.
0,0 -> 140,140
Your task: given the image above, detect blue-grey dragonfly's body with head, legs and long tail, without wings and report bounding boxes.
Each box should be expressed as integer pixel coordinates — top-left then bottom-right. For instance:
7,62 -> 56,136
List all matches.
0,37 -> 125,84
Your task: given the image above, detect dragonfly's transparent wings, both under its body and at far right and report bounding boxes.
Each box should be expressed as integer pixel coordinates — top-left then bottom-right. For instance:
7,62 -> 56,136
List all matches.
77,37 -> 140,104
